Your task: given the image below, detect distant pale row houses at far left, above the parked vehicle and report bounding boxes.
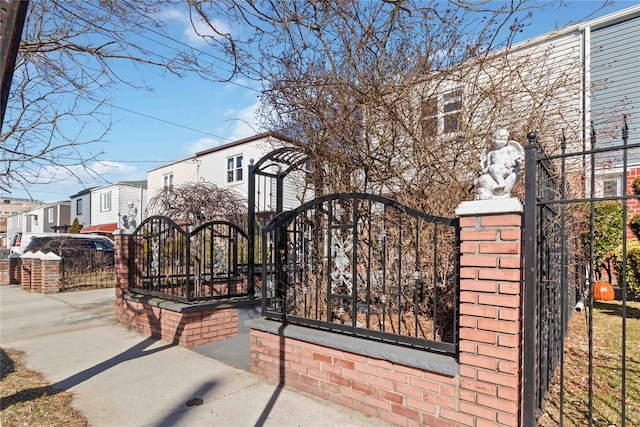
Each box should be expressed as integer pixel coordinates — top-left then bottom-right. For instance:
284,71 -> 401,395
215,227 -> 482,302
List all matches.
7,200 -> 71,244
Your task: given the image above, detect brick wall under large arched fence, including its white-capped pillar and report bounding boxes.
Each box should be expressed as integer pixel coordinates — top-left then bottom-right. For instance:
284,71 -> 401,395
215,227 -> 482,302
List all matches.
251,199 -> 523,427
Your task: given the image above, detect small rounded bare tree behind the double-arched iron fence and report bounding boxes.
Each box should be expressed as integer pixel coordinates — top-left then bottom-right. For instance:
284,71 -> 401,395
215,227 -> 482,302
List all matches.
147,182 -> 247,230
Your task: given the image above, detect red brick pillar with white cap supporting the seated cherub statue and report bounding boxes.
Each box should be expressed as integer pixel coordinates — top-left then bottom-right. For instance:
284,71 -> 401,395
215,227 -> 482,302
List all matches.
456,199 -> 523,426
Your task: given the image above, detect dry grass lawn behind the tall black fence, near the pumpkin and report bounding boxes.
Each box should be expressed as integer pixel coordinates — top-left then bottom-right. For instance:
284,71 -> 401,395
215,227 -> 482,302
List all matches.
539,301 -> 640,427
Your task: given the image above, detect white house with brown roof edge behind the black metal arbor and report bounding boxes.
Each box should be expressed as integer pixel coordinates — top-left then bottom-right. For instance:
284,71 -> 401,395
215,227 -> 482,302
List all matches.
147,132 -> 301,214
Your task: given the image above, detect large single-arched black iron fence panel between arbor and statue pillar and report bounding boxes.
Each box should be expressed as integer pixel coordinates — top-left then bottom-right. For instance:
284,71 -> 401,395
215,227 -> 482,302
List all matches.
262,193 -> 459,355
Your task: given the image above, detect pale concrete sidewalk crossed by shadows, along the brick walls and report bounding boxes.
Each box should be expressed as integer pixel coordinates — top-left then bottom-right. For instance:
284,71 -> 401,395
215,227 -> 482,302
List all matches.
0,285 -> 389,427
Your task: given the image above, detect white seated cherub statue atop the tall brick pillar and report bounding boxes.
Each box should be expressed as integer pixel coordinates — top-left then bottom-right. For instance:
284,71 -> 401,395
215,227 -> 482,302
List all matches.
475,129 -> 524,200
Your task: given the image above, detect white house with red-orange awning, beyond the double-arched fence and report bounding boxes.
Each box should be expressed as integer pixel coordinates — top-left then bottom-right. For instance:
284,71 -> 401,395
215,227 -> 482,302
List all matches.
79,181 -> 147,235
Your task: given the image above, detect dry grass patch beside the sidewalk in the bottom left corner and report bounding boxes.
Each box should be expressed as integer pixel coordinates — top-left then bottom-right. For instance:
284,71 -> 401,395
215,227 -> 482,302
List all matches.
0,349 -> 88,427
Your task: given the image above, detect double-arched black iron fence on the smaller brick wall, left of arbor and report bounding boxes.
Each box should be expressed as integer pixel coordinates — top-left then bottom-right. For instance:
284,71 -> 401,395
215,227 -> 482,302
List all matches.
129,216 -> 249,302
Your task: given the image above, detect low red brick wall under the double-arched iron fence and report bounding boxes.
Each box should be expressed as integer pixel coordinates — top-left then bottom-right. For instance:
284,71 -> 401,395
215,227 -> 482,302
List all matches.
116,294 -> 238,347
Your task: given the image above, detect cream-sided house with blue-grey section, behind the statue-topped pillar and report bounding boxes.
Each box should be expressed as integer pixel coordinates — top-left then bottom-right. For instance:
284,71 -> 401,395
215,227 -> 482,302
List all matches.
418,5 -> 640,196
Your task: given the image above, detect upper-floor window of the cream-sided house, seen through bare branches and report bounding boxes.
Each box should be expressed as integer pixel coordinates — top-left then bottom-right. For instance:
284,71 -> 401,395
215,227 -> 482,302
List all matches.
420,89 -> 462,138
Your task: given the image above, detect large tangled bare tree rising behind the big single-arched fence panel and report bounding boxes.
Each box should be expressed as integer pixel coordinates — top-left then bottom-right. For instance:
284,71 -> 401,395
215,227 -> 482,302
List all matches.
191,0 -> 604,214
